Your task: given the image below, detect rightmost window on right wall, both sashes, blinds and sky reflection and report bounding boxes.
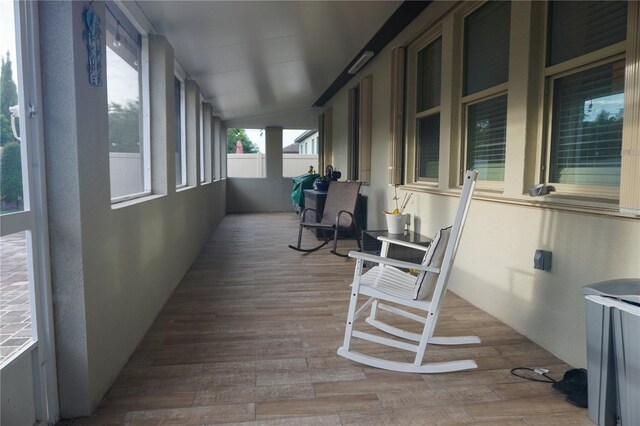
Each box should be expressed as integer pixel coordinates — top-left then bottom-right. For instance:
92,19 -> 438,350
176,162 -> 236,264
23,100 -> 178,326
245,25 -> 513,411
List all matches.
543,2 -> 627,196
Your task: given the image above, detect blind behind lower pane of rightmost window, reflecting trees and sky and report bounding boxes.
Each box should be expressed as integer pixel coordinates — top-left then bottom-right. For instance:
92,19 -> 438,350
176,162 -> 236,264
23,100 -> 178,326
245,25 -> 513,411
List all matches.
549,60 -> 625,185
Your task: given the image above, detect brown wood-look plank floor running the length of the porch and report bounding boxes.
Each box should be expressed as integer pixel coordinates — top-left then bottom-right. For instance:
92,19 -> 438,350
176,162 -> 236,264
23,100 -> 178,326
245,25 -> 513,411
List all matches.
62,213 -> 593,425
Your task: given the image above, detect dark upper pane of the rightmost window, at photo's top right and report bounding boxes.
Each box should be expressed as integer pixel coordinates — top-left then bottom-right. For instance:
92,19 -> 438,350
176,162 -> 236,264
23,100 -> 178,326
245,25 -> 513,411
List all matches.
547,1 -> 627,66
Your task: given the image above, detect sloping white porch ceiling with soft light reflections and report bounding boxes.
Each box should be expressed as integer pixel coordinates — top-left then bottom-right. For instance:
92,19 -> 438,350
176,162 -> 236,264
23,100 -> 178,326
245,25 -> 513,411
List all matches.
137,0 -> 402,129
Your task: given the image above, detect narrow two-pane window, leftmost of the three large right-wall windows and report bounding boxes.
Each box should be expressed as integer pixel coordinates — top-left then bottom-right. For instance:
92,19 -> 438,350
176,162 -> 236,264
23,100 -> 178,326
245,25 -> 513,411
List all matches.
415,38 -> 442,182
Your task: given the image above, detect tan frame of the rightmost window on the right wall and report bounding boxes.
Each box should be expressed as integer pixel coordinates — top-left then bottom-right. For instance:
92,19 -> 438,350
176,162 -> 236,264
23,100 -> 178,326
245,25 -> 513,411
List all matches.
539,4 -> 630,201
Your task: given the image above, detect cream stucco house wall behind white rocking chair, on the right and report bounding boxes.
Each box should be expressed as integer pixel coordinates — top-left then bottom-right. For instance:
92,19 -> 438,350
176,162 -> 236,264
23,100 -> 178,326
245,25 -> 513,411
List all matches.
324,2 -> 640,367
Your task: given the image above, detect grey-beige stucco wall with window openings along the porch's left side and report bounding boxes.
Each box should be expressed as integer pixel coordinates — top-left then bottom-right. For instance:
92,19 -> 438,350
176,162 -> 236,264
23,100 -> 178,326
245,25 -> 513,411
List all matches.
39,2 -> 226,418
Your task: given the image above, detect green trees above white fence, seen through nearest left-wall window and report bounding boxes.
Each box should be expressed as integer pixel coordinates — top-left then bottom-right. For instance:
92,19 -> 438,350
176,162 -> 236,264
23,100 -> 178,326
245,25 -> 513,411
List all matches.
109,101 -> 140,152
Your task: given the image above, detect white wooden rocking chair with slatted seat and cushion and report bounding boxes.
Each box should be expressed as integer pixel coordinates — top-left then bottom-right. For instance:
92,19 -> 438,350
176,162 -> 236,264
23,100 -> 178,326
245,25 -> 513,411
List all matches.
338,170 -> 480,373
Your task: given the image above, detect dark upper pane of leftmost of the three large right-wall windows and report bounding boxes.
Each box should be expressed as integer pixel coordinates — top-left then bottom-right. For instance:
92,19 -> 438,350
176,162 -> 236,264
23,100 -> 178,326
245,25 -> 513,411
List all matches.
416,38 -> 442,112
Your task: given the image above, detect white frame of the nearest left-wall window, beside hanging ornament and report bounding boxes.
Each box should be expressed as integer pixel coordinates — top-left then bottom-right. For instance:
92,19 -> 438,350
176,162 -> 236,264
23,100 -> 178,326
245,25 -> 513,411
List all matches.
105,1 -> 153,207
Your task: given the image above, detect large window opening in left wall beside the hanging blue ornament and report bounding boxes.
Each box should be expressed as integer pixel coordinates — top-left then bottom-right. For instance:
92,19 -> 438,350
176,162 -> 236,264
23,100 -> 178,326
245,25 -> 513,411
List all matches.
106,2 -> 151,202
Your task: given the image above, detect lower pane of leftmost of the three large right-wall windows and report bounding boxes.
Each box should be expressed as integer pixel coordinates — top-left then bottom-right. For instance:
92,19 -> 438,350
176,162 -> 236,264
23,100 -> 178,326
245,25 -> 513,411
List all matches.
416,113 -> 440,180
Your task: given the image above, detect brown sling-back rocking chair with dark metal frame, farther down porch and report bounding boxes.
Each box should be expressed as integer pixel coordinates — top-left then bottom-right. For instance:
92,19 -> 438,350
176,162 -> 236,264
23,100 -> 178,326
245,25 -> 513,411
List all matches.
289,182 -> 362,257
